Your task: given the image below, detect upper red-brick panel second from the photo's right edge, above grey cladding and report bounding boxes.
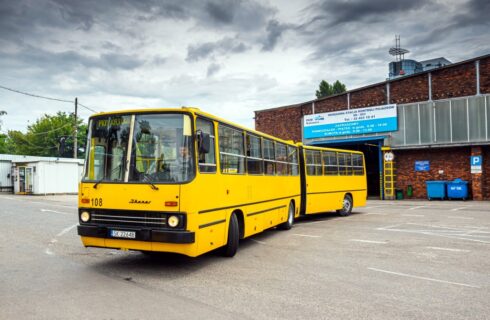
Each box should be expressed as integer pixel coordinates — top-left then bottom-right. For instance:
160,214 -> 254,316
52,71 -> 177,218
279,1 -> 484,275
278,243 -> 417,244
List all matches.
431,61 -> 476,100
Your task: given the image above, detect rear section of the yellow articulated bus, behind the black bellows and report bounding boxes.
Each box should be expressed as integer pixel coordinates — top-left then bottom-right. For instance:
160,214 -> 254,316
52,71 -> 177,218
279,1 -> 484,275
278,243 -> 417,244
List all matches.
299,144 -> 367,216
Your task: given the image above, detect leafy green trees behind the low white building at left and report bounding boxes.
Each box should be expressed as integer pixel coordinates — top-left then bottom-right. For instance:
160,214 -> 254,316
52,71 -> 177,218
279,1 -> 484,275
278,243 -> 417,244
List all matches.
6,112 -> 87,158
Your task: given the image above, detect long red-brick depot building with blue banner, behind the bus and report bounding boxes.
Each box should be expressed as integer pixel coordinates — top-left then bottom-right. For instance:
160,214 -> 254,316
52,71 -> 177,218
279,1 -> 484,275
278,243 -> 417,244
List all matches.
255,54 -> 490,200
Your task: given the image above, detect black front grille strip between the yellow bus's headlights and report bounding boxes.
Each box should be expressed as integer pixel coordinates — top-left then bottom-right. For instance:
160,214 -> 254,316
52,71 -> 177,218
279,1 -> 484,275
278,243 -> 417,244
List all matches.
90,210 -> 168,229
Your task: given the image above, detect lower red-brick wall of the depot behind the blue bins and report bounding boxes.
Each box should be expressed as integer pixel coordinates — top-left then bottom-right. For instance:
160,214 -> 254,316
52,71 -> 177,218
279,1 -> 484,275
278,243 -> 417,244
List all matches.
394,147 -> 472,199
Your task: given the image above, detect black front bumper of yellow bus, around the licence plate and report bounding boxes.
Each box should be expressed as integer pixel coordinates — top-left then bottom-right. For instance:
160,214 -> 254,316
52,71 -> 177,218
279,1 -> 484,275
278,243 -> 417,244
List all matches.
78,225 -> 195,243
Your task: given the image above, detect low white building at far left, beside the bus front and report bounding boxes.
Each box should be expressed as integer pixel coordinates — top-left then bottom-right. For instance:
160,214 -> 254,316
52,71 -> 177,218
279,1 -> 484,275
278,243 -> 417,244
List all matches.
0,154 -> 84,195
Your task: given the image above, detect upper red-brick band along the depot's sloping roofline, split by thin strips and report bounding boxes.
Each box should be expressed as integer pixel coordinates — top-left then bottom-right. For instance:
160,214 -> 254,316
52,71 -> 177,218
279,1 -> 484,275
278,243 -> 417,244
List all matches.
255,57 -> 484,141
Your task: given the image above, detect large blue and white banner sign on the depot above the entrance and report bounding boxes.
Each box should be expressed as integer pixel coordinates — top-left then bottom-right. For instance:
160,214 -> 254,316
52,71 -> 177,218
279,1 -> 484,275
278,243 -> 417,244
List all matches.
303,104 -> 398,139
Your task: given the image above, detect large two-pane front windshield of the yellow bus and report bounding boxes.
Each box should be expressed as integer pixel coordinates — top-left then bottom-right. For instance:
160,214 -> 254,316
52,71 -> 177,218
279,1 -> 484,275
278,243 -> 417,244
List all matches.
84,113 -> 195,183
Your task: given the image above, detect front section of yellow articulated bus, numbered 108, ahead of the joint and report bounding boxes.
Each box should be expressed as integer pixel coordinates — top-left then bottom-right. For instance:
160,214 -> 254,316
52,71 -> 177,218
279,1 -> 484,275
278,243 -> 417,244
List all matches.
78,108 -> 301,257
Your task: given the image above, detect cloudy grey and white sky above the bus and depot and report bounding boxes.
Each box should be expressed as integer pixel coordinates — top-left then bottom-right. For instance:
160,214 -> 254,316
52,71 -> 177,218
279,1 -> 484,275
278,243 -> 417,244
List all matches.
0,0 -> 490,132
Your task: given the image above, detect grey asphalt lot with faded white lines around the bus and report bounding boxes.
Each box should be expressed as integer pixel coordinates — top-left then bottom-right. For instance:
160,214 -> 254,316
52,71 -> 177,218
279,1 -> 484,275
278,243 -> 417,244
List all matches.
0,195 -> 490,319
